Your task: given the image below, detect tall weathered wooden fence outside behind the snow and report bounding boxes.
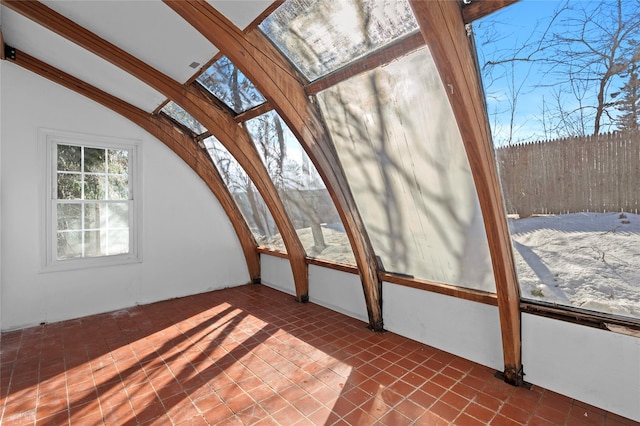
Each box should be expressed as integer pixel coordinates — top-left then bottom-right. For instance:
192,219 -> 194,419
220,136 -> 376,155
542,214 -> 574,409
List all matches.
496,132 -> 640,217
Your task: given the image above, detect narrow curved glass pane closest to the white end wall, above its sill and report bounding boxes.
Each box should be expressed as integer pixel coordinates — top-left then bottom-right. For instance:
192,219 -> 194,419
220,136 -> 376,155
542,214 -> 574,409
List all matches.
203,136 -> 286,251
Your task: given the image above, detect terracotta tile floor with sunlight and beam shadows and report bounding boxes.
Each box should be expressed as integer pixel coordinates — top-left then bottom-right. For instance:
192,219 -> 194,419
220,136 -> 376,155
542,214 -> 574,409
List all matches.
0,285 -> 638,426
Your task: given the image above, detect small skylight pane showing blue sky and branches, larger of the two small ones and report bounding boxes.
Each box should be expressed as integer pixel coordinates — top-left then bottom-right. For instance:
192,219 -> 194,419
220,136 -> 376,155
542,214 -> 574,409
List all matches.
198,56 -> 266,114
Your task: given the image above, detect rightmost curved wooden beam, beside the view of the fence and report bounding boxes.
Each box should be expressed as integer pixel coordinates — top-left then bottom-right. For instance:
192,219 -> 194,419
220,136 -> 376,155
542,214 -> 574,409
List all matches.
410,0 -> 522,385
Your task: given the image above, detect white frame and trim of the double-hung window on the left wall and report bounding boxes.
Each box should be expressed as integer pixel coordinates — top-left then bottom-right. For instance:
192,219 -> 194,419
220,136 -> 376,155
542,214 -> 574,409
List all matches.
38,129 -> 142,272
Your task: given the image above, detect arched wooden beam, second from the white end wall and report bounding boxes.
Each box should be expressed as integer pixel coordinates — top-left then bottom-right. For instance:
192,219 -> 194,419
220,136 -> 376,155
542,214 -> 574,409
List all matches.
2,0 -> 309,301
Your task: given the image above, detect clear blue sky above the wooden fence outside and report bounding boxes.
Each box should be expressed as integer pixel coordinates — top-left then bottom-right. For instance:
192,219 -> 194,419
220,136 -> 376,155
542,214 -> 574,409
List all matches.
473,0 -> 640,146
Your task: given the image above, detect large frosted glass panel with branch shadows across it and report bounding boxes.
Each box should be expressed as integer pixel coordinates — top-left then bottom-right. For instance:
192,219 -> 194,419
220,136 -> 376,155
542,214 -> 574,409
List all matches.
318,48 -> 495,291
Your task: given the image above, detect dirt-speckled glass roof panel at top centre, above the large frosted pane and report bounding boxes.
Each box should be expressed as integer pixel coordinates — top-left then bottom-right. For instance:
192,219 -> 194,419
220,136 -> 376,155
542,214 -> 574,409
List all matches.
260,0 -> 418,81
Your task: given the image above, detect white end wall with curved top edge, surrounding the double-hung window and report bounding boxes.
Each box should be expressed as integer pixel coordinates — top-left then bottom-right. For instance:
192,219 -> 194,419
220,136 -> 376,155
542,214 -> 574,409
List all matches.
0,63 -> 249,330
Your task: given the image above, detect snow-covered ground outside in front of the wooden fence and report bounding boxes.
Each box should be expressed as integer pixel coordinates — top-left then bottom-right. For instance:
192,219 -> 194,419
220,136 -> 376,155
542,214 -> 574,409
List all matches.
509,213 -> 640,318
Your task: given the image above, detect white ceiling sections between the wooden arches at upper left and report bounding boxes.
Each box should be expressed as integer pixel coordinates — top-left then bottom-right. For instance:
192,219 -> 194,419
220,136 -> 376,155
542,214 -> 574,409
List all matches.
0,0 -> 271,112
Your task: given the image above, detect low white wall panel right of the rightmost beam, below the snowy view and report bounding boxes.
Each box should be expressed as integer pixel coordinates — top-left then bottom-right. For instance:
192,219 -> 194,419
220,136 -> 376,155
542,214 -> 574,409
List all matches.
522,314 -> 640,421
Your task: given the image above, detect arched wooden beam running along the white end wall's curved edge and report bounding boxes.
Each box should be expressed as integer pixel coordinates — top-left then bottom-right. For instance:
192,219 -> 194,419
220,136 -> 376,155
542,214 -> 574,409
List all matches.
5,51 -> 260,282
